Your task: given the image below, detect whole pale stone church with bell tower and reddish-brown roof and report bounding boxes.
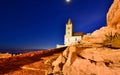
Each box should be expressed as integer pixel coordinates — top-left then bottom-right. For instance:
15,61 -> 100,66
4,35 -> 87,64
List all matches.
57,19 -> 84,48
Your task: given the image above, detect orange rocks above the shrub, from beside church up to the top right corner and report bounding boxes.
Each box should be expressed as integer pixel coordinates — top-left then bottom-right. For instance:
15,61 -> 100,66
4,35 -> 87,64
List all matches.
82,0 -> 120,44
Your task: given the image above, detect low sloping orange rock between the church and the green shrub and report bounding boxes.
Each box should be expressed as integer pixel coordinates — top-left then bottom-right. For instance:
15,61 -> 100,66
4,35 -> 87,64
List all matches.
82,27 -> 110,44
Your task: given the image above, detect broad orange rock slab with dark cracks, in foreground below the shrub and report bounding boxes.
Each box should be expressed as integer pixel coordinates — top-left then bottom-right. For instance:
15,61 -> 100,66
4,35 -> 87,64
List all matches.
62,47 -> 120,75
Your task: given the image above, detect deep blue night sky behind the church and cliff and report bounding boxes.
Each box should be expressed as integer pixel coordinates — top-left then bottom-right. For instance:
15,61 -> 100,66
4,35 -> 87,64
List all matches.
0,0 -> 113,48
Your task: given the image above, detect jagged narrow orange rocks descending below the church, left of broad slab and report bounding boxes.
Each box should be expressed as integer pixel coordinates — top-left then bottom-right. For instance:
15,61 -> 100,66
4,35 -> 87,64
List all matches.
52,46 -> 83,75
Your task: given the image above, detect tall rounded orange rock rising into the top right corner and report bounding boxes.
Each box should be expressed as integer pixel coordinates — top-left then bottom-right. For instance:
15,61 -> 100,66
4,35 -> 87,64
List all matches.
107,0 -> 120,29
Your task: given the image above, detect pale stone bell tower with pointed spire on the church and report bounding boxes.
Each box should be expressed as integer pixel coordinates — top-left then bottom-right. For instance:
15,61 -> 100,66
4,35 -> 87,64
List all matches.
64,19 -> 73,45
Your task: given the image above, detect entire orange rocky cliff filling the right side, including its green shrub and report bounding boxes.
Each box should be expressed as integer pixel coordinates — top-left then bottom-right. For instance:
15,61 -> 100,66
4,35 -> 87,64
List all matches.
48,0 -> 120,75
